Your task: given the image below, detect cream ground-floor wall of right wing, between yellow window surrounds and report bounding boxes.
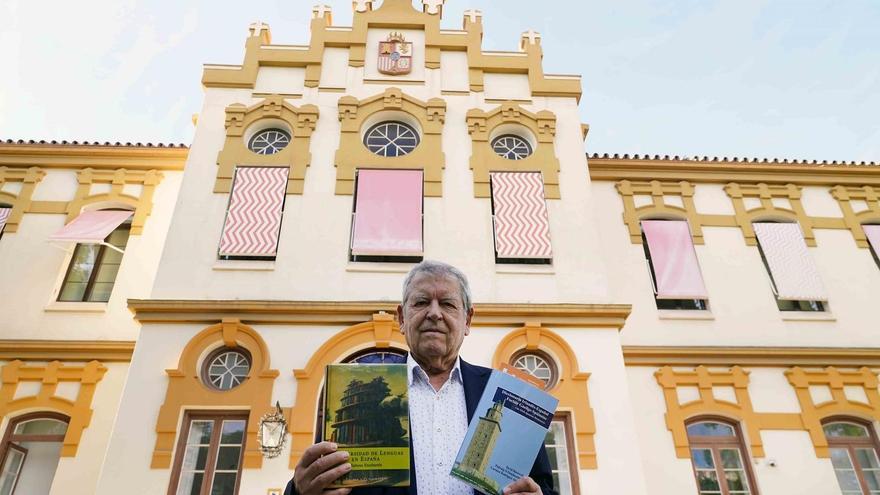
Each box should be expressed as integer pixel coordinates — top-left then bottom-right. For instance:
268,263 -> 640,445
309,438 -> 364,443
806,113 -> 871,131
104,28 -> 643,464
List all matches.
626,367 -> 840,495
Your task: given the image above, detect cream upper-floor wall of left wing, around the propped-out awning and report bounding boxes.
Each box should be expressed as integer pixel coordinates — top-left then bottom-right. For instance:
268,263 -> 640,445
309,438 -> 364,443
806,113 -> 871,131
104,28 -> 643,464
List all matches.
0,170 -> 182,340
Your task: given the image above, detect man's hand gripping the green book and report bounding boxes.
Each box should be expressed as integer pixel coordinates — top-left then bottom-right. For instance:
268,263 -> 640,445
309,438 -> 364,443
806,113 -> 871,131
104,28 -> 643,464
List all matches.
293,442 -> 351,495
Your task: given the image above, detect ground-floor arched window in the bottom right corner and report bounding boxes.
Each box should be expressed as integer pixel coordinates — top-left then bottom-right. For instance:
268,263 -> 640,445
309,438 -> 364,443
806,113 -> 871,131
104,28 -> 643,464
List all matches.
823,419 -> 880,495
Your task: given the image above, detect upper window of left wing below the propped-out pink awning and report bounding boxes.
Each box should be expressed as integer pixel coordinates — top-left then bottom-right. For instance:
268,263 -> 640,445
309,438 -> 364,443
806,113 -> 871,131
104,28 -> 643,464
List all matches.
58,209 -> 131,302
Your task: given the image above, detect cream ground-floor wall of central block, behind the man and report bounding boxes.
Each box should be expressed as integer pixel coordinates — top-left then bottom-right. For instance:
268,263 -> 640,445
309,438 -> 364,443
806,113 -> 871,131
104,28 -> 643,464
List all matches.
95,324 -> 648,495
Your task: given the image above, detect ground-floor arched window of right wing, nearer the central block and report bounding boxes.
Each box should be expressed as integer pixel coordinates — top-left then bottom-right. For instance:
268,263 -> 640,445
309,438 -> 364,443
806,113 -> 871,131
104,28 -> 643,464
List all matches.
687,419 -> 757,495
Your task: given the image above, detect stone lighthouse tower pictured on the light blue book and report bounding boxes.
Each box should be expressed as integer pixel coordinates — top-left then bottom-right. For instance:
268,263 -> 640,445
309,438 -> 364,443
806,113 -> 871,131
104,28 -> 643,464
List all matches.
452,399 -> 504,493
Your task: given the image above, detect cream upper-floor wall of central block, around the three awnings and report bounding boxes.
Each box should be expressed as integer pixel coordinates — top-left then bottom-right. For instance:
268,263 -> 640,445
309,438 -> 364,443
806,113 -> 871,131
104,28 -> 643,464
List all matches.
152,61 -> 611,302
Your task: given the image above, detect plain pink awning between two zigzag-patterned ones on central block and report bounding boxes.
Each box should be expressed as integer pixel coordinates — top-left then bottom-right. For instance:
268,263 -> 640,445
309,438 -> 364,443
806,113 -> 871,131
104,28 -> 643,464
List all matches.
351,169 -> 422,256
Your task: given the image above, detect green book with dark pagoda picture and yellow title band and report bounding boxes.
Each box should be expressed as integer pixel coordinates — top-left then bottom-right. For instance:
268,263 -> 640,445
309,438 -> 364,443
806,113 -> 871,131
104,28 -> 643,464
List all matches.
324,364 -> 410,488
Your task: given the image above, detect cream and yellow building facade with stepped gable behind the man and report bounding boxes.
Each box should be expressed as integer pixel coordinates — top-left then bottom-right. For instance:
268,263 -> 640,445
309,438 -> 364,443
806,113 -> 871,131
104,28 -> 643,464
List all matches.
0,0 -> 880,495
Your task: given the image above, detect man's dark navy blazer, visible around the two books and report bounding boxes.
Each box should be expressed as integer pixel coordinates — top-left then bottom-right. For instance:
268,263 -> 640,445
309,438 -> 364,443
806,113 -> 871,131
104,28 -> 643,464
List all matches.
284,359 -> 557,495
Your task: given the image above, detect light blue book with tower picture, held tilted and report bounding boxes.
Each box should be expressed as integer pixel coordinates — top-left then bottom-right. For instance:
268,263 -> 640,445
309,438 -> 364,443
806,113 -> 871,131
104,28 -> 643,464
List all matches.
450,370 -> 559,495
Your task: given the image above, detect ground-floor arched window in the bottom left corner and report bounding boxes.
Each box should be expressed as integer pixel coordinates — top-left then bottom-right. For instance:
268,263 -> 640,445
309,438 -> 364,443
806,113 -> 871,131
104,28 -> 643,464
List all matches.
0,413 -> 68,495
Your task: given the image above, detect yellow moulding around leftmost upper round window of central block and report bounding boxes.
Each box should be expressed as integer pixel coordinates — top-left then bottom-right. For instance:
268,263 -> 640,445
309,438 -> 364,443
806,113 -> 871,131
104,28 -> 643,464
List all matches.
214,95 -> 318,194
